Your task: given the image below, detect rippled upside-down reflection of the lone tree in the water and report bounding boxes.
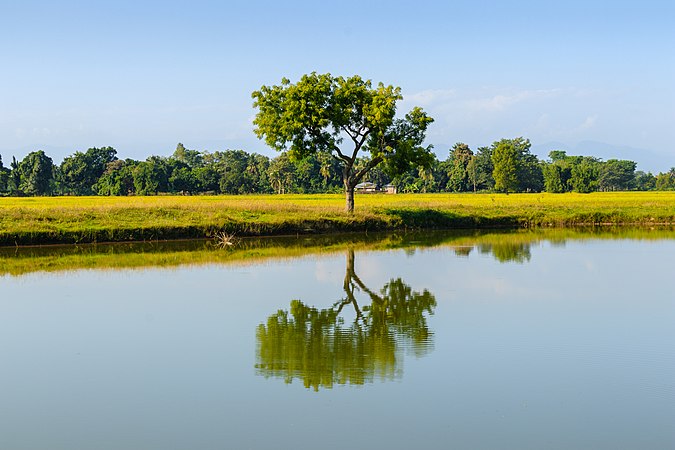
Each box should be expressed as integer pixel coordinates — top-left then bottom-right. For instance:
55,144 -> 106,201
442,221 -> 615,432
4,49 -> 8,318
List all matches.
256,250 -> 436,391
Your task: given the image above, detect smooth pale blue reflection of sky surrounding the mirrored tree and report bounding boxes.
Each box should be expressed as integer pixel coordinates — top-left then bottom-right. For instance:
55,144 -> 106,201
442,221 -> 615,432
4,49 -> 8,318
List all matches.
0,240 -> 675,449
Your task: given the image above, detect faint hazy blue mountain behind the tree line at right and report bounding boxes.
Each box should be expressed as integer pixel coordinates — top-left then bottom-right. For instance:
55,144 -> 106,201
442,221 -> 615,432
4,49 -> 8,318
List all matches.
532,141 -> 675,174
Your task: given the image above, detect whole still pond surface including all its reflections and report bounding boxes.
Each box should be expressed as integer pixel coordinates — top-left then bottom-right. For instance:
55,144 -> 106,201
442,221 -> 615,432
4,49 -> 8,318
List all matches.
0,232 -> 675,450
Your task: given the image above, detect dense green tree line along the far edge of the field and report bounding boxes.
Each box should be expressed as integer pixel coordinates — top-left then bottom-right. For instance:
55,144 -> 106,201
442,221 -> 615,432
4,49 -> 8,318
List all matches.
0,137 -> 675,196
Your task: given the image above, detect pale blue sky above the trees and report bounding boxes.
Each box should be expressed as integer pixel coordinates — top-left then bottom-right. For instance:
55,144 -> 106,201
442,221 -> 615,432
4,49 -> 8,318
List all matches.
0,0 -> 675,172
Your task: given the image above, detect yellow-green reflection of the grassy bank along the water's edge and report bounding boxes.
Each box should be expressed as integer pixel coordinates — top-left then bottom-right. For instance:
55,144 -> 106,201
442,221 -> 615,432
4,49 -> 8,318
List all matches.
0,227 -> 675,276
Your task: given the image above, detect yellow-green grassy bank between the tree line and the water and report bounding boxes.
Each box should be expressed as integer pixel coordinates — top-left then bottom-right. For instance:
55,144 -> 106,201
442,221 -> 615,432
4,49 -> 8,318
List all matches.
0,192 -> 675,246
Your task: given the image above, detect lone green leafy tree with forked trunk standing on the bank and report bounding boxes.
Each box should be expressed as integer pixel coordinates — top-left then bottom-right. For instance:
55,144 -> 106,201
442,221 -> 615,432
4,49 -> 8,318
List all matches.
252,72 -> 433,212
